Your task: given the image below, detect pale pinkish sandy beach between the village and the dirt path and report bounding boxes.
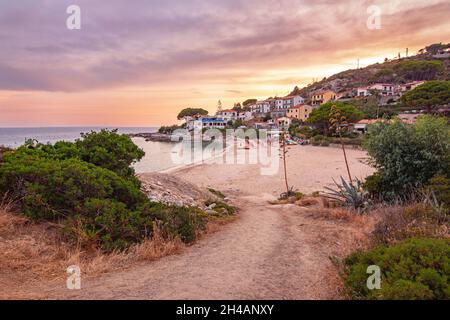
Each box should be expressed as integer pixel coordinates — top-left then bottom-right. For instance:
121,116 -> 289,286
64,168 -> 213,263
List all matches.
171,146 -> 374,197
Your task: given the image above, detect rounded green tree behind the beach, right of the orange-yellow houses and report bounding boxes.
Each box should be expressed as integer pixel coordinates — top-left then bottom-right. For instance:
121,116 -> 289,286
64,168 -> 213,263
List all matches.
307,102 -> 364,135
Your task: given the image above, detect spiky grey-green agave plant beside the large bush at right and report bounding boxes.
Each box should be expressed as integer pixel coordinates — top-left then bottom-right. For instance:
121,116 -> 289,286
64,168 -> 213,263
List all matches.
325,177 -> 369,212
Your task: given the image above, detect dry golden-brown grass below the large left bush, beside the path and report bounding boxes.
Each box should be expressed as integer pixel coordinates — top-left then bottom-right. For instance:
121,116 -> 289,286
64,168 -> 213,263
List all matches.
0,205 -> 184,299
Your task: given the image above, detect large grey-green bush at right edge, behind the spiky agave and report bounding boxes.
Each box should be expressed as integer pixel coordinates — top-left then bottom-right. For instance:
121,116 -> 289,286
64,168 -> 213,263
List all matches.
364,116 -> 450,200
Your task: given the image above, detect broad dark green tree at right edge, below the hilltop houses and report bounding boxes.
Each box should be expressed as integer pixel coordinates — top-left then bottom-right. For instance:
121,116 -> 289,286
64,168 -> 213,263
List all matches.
400,81 -> 450,113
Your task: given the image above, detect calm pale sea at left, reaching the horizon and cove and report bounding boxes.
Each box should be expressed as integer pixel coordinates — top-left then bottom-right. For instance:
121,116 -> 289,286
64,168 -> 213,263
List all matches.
0,127 -> 183,173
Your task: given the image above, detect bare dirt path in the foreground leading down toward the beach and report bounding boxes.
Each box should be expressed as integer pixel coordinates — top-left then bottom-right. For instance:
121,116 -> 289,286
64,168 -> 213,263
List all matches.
39,197 -> 356,299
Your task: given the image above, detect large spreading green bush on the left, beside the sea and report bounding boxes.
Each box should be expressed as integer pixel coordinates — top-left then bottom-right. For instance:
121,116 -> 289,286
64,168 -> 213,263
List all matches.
0,131 -> 210,251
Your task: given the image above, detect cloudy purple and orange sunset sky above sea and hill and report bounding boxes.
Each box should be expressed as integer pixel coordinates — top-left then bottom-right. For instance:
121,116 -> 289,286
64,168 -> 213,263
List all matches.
0,0 -> 450,127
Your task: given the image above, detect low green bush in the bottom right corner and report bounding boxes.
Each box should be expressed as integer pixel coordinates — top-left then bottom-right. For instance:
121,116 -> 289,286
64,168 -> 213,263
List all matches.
344,239 -> 450,300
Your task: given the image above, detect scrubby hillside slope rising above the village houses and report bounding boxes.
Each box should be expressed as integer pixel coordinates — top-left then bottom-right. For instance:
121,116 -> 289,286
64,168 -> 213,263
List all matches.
290,44 -> 450,97
